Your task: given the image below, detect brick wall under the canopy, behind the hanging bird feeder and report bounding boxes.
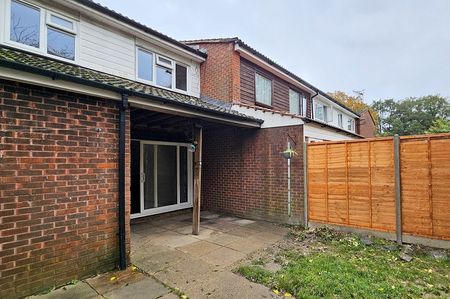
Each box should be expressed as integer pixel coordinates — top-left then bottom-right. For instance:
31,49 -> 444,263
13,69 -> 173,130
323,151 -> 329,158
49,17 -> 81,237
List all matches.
202,126 -> 304,222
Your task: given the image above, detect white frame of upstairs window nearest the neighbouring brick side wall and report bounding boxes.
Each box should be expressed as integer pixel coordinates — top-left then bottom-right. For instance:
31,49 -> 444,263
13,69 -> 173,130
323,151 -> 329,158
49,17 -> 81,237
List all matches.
135,45 -> 190,94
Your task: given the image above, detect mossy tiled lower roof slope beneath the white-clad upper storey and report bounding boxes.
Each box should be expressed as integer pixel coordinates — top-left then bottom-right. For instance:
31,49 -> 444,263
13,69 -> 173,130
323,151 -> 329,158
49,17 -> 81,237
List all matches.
0,47 -> 262,123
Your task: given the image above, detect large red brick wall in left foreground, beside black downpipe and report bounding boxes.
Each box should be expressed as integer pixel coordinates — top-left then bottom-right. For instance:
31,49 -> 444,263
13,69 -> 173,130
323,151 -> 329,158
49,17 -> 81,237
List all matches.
0,81 -> 130,298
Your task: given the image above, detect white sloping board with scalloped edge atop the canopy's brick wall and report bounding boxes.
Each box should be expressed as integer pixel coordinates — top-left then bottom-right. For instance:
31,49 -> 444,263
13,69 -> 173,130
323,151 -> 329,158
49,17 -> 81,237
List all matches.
232,105 -> 304,129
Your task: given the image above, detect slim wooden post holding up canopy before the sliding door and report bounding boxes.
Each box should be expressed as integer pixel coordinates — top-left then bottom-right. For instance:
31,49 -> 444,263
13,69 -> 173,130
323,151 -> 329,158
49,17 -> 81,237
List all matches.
192,126 -> 203,235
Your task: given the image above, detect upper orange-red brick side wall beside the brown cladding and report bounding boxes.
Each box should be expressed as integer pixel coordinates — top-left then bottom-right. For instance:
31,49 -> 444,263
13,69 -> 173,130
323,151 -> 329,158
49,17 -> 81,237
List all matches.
195,42 -> 240,102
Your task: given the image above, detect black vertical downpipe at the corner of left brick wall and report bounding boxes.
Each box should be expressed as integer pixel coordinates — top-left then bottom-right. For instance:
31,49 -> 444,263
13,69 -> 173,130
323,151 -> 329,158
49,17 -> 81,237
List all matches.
118,93 -> 128,270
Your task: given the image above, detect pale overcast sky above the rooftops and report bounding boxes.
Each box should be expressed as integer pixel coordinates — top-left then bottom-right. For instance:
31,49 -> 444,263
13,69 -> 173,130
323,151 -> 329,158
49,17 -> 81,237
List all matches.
97,0 -> 450,102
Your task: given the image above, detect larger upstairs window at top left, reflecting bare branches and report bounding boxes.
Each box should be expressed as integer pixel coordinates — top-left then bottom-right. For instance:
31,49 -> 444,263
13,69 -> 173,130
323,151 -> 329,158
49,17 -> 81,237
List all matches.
9,0 -> 77,60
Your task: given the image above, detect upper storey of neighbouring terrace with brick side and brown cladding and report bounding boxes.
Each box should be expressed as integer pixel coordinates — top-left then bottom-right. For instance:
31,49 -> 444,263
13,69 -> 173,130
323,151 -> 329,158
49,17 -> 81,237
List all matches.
184,37 -> 361,142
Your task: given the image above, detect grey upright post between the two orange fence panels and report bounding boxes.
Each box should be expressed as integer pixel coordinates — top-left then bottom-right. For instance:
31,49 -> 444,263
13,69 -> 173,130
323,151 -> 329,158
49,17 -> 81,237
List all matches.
394,134 -> 403,244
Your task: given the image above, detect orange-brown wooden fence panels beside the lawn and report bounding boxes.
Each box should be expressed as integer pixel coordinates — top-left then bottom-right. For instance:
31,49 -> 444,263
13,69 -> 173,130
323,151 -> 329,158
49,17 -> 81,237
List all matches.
307,134 -> 450,240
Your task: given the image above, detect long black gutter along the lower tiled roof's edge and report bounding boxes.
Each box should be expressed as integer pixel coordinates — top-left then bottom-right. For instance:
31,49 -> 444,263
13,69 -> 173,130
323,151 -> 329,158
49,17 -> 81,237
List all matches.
0,60 -> 264,125
